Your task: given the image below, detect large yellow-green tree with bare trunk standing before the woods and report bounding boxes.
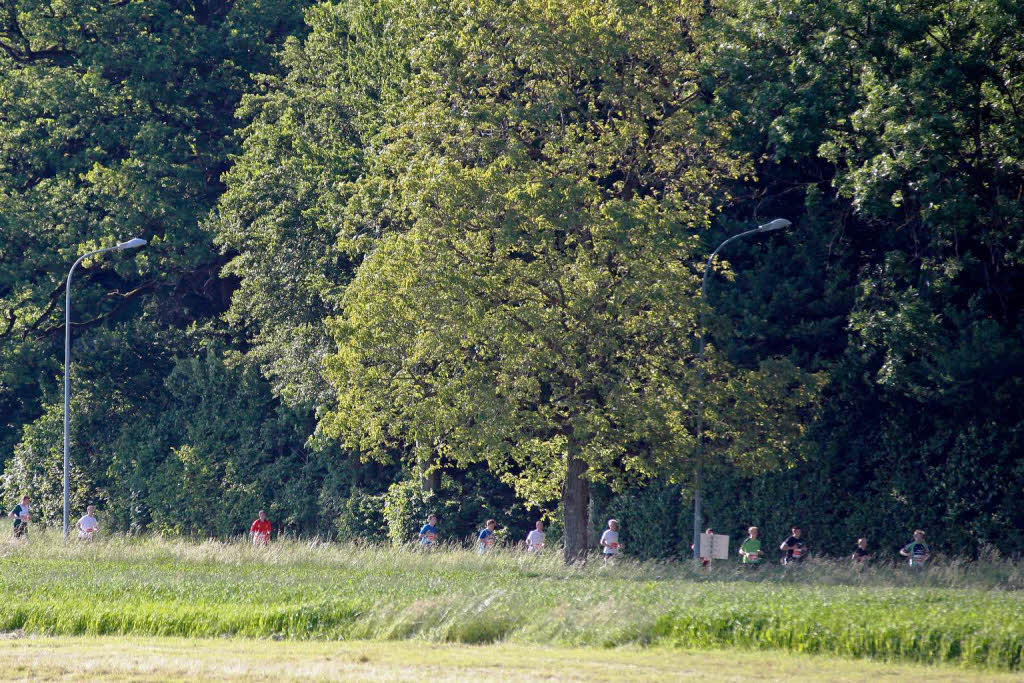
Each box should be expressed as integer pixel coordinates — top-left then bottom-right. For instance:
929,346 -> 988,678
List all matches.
321,2 -> 808,561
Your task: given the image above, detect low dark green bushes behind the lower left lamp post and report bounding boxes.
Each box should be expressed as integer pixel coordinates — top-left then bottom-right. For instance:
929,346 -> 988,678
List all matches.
4,351 -> 362,537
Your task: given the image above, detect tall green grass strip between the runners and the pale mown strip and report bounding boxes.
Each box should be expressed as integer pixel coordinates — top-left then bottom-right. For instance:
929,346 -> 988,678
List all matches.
0,536 -> 1024,672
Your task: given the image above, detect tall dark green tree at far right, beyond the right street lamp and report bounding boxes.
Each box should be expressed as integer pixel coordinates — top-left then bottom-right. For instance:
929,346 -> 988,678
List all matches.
699,0 -> 1024,552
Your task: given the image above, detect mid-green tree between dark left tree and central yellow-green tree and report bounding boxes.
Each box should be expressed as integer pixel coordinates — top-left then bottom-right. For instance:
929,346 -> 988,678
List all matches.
210,0 -> 416,410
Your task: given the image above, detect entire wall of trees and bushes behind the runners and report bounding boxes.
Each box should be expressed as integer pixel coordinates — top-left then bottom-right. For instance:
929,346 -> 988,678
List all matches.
0,0 -> 1024,556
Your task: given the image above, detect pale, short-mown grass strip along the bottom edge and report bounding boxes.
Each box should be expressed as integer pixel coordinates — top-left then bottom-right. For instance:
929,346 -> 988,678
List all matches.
0,636 -> 1020,683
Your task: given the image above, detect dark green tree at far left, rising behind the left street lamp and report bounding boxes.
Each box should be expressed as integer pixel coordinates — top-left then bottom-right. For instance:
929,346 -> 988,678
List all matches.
0,0 -> 311,520
